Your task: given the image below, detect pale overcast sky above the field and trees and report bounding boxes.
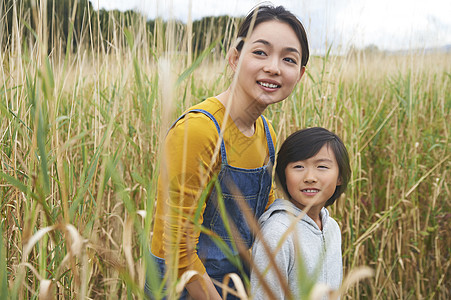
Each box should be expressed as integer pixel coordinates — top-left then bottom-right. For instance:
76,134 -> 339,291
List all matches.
90,0 -> 451,53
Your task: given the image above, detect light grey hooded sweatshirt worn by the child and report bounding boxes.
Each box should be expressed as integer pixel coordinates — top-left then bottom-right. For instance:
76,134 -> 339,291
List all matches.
251,199 -> 343,299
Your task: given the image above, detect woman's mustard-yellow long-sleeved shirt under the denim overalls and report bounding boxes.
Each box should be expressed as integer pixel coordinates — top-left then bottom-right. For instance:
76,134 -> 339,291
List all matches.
151,98 -> 276,276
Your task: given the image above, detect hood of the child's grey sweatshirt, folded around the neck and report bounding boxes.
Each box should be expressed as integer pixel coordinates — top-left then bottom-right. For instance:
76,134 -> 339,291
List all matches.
258,199 -> 329,234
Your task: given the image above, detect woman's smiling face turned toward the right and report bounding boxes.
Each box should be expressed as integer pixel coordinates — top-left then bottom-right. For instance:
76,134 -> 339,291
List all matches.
231,20 -> 305,107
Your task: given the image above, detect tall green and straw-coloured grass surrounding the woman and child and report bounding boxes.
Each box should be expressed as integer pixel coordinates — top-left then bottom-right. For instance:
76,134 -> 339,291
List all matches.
0,2 -> 451,299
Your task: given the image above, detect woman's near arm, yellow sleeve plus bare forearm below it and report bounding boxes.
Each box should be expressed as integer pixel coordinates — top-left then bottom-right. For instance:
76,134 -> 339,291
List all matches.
164,114 -> 221,300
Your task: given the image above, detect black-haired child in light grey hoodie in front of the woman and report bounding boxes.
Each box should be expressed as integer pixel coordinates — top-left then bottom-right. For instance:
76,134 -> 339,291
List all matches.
251,127 -> 351,299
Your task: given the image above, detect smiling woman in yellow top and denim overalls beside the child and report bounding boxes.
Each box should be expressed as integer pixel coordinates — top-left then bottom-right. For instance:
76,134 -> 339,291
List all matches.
146,6 -> 309,299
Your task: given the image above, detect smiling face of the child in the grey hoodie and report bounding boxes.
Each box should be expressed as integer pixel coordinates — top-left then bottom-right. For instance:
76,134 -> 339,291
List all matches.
285,145 -> 341,218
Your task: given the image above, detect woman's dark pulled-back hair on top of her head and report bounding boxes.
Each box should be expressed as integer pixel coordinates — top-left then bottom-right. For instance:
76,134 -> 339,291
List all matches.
236,5 -> 310,67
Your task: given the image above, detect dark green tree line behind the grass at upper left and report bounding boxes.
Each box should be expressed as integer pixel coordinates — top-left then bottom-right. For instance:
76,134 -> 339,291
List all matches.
0,0 -> 239,54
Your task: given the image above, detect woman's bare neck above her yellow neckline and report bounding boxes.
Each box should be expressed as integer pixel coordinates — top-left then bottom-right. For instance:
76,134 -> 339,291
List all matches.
216,88 -> 266,137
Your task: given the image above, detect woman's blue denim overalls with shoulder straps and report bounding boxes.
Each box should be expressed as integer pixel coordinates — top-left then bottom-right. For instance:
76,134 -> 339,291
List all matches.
146,109 -> 275,299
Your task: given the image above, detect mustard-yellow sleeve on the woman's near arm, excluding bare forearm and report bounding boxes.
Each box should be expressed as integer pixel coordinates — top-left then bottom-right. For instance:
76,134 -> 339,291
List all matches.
152,113 -> 218,276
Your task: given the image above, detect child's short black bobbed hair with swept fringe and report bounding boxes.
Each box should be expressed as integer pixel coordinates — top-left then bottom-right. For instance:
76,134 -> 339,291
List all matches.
276,127 -> 351,207
